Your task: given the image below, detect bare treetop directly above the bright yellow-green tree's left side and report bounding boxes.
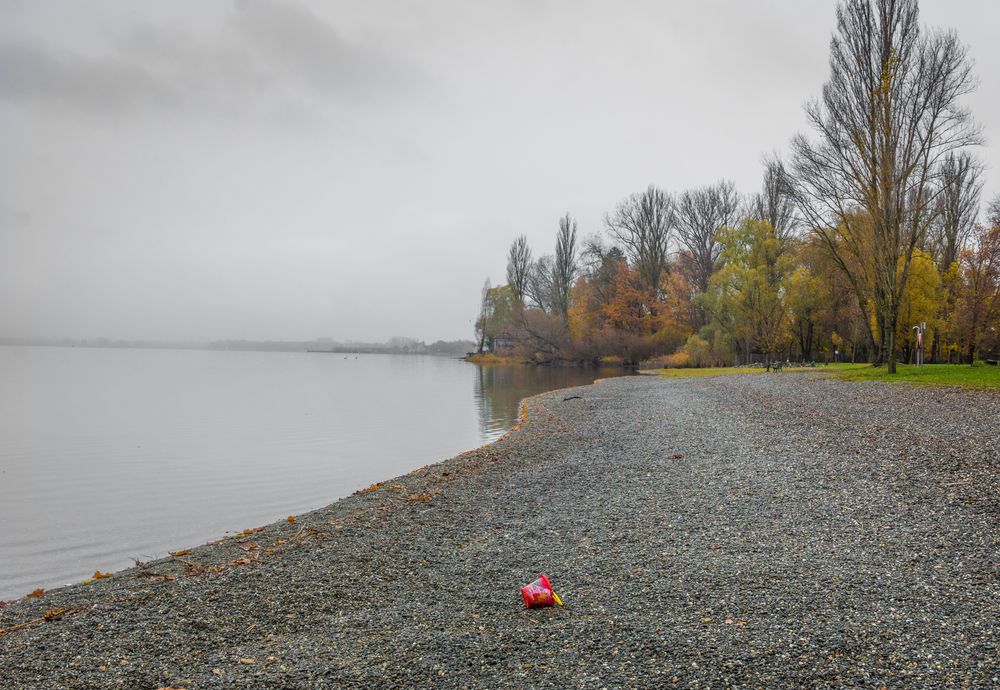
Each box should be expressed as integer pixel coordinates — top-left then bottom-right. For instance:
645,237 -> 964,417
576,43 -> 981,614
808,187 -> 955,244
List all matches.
677,181 -> 740,292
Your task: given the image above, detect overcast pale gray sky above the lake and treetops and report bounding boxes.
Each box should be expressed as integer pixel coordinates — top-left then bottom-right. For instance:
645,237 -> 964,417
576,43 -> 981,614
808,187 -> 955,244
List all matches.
0,0 -> 1000,340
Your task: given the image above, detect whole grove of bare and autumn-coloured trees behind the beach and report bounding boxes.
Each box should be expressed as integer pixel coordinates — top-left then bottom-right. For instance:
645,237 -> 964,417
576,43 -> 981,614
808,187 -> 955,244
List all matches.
476,0 -> 1000,371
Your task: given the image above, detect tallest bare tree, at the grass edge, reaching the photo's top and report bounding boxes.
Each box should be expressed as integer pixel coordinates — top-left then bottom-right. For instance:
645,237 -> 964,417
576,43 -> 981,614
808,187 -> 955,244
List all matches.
792,0 -> 980,372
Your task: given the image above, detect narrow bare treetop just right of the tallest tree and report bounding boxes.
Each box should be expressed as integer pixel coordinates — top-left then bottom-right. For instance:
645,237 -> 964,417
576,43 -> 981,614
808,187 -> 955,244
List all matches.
930,151 -> 983,271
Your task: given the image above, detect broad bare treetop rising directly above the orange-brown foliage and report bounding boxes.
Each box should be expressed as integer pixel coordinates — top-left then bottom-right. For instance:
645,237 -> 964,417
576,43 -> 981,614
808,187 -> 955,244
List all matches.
604,185 -> 676,294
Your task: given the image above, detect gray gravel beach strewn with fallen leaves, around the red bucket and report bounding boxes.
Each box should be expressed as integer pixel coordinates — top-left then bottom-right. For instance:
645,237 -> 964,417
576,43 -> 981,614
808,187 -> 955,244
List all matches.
0,373 -> 1000,690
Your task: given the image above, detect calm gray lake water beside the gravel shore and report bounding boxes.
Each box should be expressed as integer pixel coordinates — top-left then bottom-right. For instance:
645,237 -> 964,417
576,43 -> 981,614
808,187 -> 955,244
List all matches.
0,347 -> 622,599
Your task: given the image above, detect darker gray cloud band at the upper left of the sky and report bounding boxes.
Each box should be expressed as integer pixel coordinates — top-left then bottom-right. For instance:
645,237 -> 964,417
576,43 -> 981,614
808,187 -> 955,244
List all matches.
0,0 -> 420,115
